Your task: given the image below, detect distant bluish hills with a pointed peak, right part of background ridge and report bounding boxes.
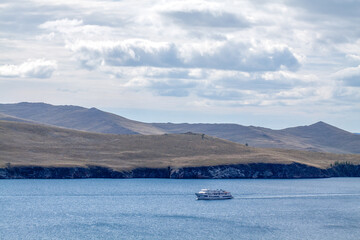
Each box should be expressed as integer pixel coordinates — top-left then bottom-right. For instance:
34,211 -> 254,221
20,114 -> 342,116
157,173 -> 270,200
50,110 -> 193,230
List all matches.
154,122 -> 360,154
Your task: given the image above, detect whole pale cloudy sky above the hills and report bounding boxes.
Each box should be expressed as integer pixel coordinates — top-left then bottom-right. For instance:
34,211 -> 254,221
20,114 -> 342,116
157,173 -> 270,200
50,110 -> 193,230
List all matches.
0,0 -> 360,132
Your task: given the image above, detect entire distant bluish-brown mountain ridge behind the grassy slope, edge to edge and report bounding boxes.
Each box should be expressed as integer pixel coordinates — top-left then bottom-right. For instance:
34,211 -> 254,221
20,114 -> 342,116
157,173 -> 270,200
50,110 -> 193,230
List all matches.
0,103 -> 360,154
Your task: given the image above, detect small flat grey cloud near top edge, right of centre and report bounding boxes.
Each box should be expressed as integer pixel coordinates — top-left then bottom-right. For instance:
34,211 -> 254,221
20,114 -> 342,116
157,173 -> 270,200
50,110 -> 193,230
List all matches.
163,10 -> 250,28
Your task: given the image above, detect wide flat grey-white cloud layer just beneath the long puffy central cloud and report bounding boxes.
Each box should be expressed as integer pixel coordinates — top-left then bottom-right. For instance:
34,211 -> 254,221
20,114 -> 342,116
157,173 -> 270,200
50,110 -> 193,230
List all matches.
114,67 -> 320,102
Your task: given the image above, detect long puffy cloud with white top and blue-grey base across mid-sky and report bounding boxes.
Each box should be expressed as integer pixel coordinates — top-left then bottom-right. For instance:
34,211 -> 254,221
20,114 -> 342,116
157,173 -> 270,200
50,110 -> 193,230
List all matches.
68,39 -> 300,71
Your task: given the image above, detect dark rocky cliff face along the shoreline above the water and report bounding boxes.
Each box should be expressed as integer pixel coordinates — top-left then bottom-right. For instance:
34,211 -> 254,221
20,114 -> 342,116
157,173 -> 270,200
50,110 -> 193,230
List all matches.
0,163 -> 360,179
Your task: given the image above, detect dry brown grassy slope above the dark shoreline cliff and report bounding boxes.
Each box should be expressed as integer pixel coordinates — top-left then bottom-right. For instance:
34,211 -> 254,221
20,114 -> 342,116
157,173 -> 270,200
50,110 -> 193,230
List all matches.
0,121 -> 360,170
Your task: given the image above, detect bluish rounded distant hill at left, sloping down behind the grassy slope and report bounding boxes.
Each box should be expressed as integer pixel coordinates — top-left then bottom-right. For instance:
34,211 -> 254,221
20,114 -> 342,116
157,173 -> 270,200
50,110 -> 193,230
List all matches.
0,103 -> 165,135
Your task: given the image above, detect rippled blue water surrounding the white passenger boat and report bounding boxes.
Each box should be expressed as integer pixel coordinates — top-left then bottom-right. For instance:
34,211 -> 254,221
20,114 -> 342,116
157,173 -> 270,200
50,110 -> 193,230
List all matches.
0,178 -> 360,239
